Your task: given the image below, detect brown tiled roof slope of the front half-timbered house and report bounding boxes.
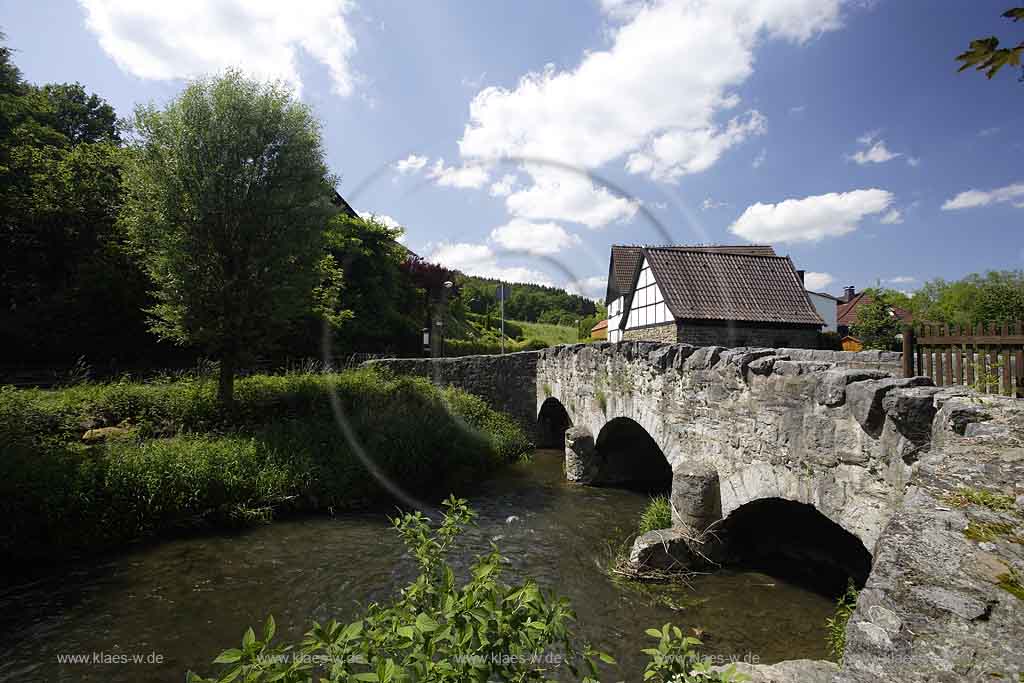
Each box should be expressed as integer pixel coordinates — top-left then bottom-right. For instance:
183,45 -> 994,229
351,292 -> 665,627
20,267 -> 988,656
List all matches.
644,247 -> 824,326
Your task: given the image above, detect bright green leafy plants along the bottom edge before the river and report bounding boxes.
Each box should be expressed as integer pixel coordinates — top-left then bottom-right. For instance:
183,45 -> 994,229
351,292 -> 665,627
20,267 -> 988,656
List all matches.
187,498 -> 745,683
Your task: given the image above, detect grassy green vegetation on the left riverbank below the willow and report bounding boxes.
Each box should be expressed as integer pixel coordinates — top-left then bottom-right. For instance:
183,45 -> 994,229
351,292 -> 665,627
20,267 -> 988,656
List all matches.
0,370 -> 531,570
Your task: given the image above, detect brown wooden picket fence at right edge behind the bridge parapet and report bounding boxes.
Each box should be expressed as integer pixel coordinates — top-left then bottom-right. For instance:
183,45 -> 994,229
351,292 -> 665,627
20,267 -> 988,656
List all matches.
903,322 -> 1024,398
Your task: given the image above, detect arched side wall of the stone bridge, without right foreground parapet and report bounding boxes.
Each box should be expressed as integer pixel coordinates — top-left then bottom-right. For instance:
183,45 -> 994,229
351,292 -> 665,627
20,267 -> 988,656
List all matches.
374,342 -> 917,550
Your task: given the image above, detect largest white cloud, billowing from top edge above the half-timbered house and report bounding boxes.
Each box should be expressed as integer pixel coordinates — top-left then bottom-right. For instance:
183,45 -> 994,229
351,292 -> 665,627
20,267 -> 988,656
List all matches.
459,0 -> 840,227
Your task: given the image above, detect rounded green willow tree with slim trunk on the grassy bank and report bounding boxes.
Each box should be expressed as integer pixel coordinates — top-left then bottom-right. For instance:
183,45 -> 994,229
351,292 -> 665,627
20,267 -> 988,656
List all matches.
121,71 -> 340,402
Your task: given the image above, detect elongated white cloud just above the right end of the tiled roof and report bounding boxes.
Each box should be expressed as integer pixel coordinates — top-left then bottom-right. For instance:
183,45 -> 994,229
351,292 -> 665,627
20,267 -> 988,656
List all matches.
729,189 -> 895,244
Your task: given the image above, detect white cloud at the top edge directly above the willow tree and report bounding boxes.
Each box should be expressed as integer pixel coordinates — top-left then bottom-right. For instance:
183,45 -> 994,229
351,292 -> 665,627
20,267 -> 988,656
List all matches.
79,0 -> 356,95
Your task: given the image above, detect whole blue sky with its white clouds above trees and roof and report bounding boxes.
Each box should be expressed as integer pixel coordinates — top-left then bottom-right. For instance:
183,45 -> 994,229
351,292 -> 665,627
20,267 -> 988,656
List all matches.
0,0 -> 1024,296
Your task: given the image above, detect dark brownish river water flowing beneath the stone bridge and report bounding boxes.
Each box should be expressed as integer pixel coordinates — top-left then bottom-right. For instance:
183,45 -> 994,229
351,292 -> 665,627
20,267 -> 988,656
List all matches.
0,451 -> 831,683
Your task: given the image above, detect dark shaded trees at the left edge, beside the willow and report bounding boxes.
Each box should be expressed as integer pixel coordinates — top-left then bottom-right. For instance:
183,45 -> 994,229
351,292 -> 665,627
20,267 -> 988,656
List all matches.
0,34 -> 153,364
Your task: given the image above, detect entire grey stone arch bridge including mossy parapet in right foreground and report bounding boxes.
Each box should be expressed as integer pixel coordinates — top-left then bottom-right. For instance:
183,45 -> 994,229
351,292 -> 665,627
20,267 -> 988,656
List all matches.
369,342 -> 1024,683
